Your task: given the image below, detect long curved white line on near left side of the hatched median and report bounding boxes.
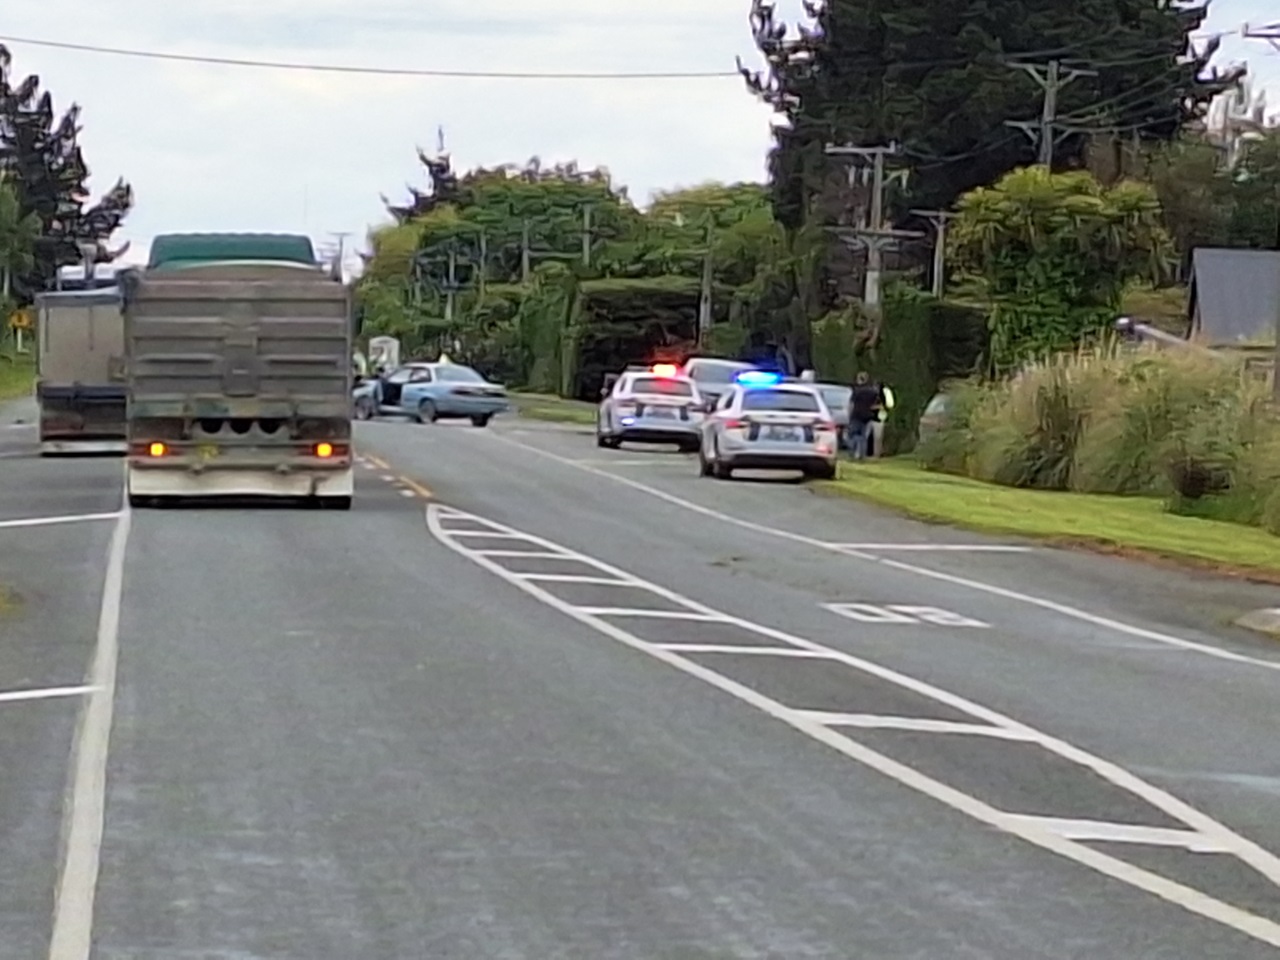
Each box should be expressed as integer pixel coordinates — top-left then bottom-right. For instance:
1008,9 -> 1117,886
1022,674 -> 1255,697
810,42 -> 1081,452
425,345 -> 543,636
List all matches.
426,504 -> 1280,947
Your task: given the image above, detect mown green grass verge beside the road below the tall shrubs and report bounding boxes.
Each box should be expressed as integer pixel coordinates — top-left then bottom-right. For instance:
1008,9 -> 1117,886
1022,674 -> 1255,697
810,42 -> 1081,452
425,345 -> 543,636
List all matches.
828,458 -> 1280,582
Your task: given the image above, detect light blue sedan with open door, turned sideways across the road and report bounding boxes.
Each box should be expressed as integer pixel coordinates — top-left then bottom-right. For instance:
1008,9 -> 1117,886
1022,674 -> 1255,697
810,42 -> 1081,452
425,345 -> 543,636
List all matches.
352,364 -> 511,426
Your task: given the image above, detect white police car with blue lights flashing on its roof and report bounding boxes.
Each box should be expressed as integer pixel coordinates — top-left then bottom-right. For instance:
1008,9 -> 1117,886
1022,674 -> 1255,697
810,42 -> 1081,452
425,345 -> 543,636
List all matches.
698,370 -> 838,480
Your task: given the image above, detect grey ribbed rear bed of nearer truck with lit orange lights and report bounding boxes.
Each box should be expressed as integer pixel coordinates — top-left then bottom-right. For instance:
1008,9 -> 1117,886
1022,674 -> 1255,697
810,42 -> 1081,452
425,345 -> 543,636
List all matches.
122,262 -> 353,500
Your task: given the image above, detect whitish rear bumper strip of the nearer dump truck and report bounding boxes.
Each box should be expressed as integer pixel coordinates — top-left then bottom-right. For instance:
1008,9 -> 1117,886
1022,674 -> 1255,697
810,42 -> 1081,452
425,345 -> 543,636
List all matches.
127,463 -> 356,498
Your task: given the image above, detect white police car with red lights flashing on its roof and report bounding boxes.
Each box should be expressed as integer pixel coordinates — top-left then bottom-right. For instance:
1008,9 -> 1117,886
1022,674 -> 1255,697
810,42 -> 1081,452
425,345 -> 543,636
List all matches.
595,364 -> 707,453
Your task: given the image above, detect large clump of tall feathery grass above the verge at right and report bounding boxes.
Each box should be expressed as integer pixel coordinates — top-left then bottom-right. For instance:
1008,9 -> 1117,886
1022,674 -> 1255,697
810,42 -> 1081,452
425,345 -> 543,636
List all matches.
920,344 -> 1280,532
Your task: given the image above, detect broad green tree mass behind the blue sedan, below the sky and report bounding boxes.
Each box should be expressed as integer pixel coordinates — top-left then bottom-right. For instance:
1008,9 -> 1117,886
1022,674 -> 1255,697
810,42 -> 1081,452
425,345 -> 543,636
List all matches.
357,154 -> 790,389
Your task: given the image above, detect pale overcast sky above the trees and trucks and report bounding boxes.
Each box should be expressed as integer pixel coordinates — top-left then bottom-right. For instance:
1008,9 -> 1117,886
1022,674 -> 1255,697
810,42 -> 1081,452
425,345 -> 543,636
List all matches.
0,0 -> 1280,271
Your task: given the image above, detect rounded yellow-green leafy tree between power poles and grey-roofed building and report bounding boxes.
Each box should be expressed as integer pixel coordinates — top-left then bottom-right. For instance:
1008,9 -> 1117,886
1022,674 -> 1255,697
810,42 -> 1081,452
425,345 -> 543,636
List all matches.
951,166 -> 1172,370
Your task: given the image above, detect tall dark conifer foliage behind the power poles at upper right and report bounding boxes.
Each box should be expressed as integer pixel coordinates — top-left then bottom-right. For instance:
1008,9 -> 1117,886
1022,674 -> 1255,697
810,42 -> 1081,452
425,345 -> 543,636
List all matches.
744,0 -> 1234,228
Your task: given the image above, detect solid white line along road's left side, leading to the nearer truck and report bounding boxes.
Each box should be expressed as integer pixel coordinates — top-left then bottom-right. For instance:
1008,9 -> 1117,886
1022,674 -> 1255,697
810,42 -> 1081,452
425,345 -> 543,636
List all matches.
49,508 -> 132,960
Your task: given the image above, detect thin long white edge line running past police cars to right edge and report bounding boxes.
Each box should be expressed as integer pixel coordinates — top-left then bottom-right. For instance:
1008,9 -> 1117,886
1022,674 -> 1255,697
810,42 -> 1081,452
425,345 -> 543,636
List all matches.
490,434 -> 1280,671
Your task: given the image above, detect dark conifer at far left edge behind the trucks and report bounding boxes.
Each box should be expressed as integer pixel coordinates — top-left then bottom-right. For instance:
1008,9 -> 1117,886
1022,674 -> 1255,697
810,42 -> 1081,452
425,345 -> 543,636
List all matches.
0,46 -> 133,297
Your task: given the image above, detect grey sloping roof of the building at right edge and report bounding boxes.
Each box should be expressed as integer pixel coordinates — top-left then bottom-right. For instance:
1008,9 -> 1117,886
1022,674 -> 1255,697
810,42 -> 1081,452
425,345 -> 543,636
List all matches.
1192,247 -> 1280,347
